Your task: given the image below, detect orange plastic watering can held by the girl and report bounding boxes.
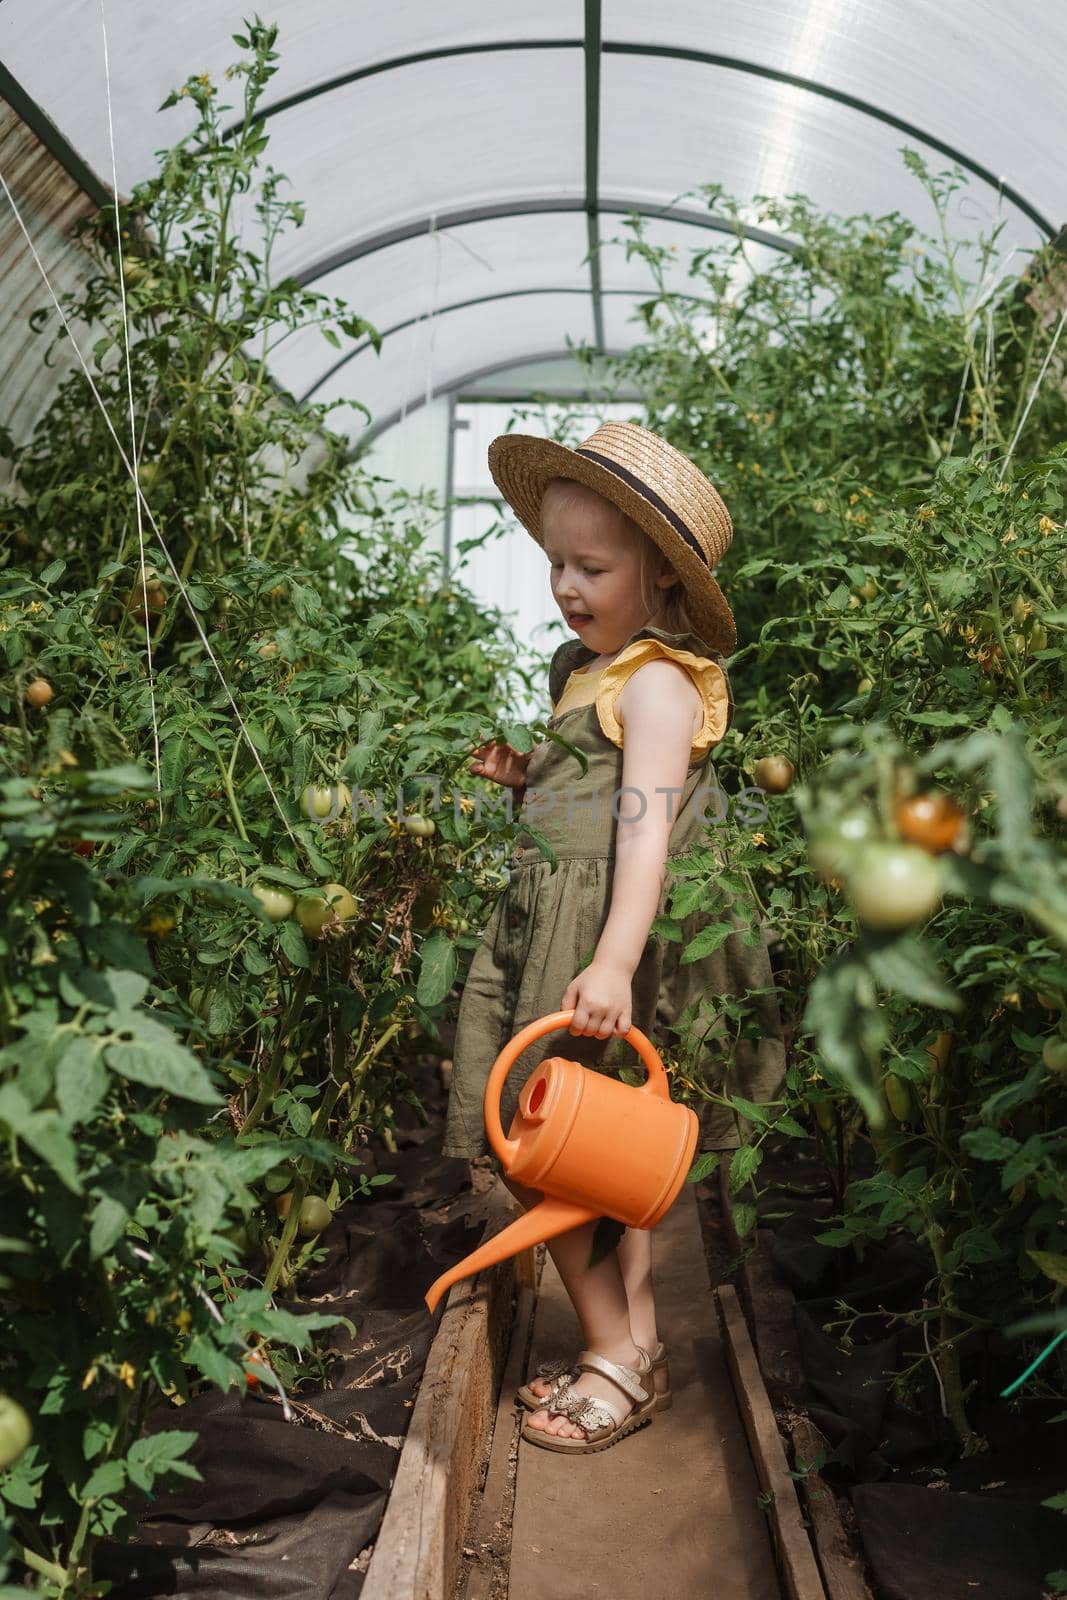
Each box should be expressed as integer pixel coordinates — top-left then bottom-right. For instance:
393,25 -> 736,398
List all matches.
426,1011 -> 697,1310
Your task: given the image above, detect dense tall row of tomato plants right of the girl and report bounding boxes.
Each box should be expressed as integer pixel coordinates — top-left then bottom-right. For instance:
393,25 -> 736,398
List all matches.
606,162 -> 1067,1484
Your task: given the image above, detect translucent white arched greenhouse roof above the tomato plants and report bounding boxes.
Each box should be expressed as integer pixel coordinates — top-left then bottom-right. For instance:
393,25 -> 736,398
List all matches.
0,0 -> 1067,444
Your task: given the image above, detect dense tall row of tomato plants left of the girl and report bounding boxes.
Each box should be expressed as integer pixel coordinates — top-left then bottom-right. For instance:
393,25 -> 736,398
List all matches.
0,24 -> 531,1600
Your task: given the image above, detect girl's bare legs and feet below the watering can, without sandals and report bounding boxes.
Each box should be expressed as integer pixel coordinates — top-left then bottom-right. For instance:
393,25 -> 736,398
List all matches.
504,1178 -> 654,1438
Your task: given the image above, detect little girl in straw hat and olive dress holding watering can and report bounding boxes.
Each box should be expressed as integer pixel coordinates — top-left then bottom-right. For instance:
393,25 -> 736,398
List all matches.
443,422 -> 784,1453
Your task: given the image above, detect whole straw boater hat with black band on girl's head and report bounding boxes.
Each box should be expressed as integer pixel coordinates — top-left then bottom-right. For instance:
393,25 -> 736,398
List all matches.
490,422 -> 737,656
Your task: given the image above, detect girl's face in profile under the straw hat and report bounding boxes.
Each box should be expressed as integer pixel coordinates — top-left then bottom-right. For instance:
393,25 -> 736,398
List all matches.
541,490 -> 673,656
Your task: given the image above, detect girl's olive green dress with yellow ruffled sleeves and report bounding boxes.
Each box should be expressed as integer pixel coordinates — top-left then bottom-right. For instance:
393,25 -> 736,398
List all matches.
442,627 -> 785,1157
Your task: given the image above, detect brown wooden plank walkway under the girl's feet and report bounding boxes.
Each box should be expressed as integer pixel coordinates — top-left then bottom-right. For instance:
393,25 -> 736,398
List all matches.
502,1186 -> 781,1600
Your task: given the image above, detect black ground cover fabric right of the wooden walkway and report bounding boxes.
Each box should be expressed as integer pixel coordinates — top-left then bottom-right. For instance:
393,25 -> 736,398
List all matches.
757,1139 -> 1067,1600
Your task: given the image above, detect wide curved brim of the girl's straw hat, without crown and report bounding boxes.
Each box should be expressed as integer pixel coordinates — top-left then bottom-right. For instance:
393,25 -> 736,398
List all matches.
488,434 -> 737,656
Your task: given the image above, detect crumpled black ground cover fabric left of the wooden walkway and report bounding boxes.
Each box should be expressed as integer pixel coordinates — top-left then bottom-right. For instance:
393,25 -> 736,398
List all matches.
99,1067 -> 488,1600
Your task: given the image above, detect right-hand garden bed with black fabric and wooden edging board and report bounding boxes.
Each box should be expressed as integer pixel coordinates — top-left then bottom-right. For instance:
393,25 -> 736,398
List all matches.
702,1134 -> 1062,1600
